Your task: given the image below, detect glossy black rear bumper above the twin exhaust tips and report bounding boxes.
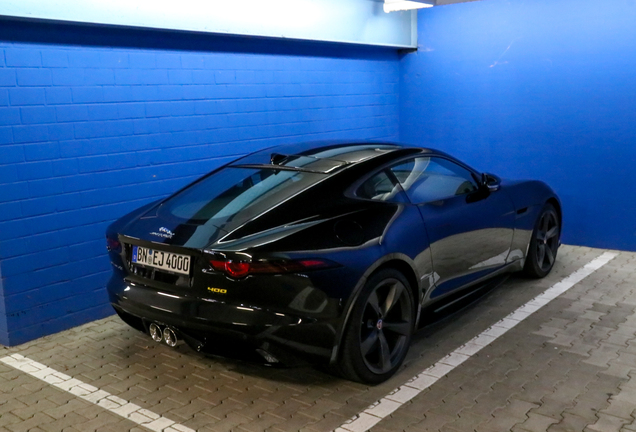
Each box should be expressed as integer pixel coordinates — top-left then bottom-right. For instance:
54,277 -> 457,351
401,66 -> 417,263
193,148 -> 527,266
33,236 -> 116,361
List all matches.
108,276 -> 340,364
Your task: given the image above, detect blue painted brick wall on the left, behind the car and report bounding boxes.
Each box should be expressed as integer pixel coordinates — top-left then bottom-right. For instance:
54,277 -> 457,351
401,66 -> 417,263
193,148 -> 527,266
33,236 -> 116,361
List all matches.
0,22 -> 399,345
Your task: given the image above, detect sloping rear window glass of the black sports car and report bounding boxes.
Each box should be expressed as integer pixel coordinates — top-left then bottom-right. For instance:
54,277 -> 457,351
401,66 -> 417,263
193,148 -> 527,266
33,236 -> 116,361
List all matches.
159,166 -> 325,225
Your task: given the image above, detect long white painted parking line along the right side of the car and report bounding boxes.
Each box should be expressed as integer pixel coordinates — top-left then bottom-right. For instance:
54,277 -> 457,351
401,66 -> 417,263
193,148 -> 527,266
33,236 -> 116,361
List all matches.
335,252 -> 618,432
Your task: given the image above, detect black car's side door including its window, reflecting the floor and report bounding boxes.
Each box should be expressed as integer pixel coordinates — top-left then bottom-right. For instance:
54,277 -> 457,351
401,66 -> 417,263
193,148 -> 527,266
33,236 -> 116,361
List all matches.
390,156 -> 515,298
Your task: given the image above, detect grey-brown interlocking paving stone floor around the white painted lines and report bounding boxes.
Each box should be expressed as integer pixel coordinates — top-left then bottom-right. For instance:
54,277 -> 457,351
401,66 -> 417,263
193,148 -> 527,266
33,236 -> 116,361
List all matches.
0,246 -> 636,432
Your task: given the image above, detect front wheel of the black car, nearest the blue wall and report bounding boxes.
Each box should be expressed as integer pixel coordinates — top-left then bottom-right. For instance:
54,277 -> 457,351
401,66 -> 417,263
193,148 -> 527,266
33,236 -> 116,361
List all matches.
523,203 -> 561,279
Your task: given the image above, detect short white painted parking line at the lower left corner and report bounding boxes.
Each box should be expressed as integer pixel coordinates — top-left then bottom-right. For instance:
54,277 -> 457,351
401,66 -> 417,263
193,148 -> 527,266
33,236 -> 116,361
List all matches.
0,354 -> 195,432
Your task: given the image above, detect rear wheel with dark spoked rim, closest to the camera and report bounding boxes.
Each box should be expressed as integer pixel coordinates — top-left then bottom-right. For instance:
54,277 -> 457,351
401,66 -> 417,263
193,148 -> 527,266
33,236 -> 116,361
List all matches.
338,269 -> 415,384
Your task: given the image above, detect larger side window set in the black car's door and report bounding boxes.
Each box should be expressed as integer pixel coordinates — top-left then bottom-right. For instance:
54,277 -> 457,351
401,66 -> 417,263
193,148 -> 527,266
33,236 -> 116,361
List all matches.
391,157 -> 478,204
